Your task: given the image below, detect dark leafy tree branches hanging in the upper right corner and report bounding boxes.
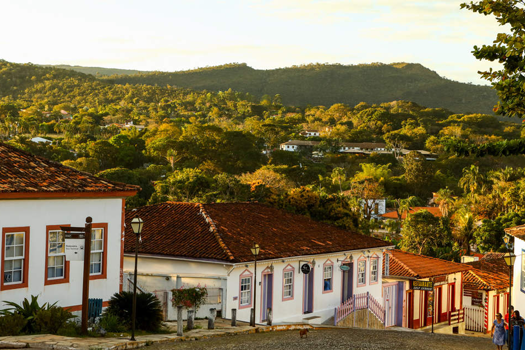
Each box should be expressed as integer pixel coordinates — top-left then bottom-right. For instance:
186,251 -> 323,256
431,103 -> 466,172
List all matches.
461,0 -> 525,118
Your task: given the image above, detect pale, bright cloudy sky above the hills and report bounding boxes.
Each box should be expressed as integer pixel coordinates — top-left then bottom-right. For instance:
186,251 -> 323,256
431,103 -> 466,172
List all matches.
0,0 -> 505,84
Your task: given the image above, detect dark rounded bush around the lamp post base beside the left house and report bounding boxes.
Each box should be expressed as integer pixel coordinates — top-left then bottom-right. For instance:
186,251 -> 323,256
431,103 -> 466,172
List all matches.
104,292 -> 162,331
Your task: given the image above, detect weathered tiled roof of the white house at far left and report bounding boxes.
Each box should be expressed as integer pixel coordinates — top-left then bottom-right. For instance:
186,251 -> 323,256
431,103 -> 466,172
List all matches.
0,143 -> 140,198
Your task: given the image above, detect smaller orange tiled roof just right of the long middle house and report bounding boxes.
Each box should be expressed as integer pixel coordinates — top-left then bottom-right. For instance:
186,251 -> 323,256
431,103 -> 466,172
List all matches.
383,249 -> 472,279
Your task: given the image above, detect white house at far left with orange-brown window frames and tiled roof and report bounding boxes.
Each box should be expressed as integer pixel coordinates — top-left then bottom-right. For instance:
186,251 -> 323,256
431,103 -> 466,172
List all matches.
0,143 -> 139,311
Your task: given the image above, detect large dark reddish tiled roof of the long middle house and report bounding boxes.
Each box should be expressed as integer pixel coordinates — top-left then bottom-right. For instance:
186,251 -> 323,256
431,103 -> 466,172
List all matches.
125,202 -> 390,262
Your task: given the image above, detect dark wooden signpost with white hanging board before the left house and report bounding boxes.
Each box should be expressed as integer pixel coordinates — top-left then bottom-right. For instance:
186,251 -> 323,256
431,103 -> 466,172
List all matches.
60,216 -> 93,335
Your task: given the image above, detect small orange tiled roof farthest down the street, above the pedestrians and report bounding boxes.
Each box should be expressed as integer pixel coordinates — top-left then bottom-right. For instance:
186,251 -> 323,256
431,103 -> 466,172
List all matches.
464,253 -> 509,290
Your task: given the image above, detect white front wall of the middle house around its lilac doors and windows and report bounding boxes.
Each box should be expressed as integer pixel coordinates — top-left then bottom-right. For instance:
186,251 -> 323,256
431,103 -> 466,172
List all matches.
225,249 -> 383,323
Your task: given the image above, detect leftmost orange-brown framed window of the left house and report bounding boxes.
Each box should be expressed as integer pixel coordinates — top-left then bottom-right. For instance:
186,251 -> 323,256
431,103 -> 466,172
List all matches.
0,227 -> 29,290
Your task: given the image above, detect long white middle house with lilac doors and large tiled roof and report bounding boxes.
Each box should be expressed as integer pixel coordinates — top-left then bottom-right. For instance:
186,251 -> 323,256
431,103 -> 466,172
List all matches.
124,202 -> 390,324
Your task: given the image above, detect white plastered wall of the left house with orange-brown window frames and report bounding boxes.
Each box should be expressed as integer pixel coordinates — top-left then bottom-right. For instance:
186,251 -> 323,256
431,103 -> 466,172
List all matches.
0,198 -> 122,308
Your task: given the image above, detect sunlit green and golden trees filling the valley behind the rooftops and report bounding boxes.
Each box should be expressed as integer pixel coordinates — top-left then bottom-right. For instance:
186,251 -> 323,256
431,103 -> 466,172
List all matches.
0,61 -> 525,258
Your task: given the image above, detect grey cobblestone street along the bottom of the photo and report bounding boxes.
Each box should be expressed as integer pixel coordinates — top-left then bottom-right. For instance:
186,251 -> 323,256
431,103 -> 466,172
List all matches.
148,329 -> 495,350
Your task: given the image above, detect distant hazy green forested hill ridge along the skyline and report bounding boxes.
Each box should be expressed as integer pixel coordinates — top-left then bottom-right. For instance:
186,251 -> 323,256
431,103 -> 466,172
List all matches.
99,63 -> 497,114
